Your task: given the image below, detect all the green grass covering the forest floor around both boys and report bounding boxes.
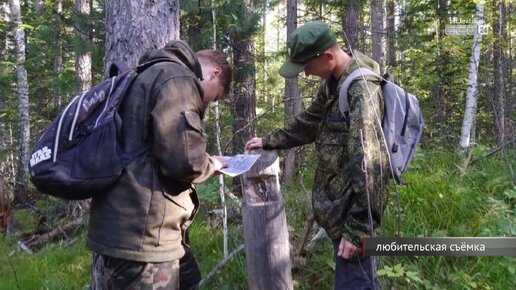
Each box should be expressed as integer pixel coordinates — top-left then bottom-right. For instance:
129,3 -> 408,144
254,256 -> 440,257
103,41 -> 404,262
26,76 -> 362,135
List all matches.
0,150 -> 516,290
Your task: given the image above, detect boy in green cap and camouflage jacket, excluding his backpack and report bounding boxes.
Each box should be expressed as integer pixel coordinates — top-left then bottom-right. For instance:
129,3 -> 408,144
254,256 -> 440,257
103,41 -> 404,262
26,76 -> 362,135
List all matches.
246,21 -> 389,289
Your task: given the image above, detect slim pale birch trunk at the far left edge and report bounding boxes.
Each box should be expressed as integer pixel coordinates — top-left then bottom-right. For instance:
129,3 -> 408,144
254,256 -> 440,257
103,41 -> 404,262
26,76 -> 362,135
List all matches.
9,0 -> 30,203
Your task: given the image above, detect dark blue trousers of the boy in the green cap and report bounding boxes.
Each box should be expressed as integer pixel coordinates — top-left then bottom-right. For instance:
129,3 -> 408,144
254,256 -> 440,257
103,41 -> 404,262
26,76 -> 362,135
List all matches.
333,240 -> 381,290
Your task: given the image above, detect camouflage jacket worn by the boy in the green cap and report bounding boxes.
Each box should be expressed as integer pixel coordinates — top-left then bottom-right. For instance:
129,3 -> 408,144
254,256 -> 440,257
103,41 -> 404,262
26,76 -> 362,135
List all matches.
263,51 -> 389,246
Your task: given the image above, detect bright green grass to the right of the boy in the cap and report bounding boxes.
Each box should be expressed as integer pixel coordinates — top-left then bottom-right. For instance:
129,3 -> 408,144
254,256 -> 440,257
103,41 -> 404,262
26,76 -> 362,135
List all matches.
381,148 -> 516,289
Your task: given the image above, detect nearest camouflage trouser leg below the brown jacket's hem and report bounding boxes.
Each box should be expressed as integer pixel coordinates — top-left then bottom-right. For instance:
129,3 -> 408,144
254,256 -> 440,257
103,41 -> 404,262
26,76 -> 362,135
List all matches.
91,252 -> 180,290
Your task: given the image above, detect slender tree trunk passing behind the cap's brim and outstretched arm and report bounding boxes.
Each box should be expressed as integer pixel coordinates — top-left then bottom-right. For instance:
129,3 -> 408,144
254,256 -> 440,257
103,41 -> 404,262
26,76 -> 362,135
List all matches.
283,0 -> 302,185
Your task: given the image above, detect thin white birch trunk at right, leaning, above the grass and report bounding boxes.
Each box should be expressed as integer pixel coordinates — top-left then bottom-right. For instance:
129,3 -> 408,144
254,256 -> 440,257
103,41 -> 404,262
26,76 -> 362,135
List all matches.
459,1 -> 484,152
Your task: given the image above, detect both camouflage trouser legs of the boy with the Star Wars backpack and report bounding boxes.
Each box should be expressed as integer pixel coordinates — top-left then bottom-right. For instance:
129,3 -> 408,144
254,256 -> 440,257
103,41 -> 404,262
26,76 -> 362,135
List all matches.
91,249 -> 201,290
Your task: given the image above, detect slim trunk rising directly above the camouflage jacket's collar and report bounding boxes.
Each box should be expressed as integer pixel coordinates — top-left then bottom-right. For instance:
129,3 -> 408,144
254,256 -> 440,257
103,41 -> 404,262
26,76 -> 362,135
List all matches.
371,0 -> 385,73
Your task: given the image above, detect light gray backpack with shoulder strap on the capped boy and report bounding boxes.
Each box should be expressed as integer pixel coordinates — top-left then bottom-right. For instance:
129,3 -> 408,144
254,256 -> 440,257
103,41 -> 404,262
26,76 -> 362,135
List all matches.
339,68 -> 425,184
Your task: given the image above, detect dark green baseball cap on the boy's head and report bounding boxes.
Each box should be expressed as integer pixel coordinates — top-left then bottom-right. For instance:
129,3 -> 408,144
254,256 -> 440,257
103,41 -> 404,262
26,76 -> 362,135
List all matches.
279,21 -> 337,78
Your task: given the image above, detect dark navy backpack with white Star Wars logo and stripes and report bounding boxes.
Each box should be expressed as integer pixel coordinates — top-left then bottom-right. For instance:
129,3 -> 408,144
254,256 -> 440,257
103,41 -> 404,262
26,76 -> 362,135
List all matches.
29,63 -> 148,200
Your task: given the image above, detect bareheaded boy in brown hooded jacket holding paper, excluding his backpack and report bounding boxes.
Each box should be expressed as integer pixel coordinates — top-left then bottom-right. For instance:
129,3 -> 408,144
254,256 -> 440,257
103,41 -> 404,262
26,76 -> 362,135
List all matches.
87,40 -> 231,290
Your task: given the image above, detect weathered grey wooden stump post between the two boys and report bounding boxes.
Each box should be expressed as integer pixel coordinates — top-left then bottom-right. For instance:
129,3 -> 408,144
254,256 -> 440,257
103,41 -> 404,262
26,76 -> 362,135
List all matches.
241,151 -> 293,290
